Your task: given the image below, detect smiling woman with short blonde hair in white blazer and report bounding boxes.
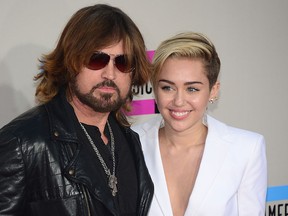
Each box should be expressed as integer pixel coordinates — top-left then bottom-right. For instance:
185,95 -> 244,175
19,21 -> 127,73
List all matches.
133,32 -> 267,216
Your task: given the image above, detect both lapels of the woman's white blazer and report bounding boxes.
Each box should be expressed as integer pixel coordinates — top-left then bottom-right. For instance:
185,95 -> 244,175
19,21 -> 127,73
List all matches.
139,116 -> 229,216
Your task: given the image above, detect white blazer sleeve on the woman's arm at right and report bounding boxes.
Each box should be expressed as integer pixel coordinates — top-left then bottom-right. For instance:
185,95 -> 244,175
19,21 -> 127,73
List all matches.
238,135 -> 267,216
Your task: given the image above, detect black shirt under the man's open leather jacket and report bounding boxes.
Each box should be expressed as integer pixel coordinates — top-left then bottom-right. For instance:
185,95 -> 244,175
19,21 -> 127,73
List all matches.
77,116 -> 138,216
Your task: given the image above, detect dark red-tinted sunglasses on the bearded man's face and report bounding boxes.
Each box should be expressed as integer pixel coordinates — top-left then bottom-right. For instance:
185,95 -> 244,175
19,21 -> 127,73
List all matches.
86,51 -> 131,73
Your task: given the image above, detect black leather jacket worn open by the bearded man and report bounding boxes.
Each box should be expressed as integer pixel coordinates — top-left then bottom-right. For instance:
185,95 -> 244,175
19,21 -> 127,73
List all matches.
0,93 -> 153,216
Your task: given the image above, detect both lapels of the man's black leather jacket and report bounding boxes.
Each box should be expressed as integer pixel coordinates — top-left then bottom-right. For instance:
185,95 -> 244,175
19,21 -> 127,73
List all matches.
45,89 -> 153,215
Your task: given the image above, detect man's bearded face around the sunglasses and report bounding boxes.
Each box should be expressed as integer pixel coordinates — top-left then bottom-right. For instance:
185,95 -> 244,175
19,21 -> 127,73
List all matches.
71,41 -> 132,113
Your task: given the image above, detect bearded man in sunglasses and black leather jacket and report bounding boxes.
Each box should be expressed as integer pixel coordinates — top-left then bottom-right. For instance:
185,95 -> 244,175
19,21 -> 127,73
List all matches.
0,4 -> 153,216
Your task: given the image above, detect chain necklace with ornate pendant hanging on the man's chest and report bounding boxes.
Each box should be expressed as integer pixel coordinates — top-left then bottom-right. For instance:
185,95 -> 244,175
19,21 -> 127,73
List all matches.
79,122 -> 118,196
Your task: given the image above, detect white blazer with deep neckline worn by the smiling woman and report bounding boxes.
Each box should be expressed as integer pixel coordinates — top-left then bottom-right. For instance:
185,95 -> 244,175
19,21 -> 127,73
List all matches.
132,115 -> 267,216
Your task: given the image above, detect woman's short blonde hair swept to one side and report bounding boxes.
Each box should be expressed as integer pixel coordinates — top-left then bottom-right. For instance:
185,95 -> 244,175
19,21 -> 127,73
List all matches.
150,32 -> 221,89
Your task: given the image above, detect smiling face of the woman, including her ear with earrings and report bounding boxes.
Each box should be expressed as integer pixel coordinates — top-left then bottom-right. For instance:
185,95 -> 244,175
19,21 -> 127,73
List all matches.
155,57 -> 219,132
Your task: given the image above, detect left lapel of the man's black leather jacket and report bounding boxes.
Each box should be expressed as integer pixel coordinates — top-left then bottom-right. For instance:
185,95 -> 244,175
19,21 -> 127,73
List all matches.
45,89 -> 117,215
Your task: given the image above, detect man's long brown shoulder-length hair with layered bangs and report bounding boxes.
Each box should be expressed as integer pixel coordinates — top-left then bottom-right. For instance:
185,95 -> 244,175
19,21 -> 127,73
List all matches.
34,4 -> 151,125
